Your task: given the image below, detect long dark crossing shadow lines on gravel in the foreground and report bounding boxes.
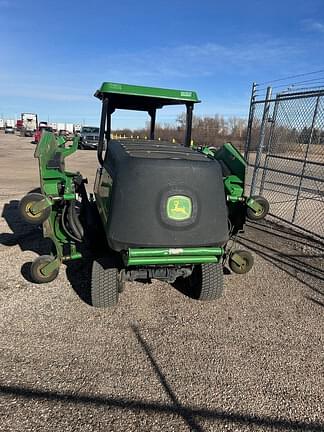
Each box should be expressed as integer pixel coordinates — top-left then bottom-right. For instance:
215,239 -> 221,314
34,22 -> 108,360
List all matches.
0,324 -> 324,432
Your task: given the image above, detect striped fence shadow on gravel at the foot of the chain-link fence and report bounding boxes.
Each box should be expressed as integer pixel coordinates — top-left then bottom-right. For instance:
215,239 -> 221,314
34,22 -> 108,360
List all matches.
238,221 -> 324,306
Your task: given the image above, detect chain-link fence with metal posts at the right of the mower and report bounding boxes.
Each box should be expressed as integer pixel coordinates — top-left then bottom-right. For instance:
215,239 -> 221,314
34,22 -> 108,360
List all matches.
245,85 -> 324,237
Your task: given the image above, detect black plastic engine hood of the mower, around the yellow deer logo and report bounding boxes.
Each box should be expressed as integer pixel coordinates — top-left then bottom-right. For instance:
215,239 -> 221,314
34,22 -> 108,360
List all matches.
104,140 -> 228,251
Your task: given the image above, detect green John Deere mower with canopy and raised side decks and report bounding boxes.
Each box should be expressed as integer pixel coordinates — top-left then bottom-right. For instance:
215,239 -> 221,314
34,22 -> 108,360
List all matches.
19,82 -> 269,307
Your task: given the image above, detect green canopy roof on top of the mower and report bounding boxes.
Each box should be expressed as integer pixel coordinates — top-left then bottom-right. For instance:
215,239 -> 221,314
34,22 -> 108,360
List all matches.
95,82 -> 200,111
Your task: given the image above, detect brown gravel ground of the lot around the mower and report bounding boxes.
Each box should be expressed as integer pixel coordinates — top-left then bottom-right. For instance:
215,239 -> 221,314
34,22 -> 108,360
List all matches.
0,135 -> 324,432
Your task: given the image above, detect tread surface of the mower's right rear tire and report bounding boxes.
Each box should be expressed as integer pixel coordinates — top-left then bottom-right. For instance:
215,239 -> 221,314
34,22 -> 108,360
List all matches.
197,263 -> 224,301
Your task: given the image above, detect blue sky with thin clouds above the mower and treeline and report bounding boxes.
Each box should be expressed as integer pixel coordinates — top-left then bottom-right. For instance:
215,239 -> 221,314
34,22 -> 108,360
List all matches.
0,0 -> 324,127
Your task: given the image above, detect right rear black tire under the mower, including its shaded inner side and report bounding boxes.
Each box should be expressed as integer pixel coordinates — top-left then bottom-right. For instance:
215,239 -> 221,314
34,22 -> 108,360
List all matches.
186,263 -> 224,301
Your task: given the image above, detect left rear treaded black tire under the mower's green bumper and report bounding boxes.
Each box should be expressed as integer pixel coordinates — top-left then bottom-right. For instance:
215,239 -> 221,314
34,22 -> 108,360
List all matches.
91,258 -> 120,308
